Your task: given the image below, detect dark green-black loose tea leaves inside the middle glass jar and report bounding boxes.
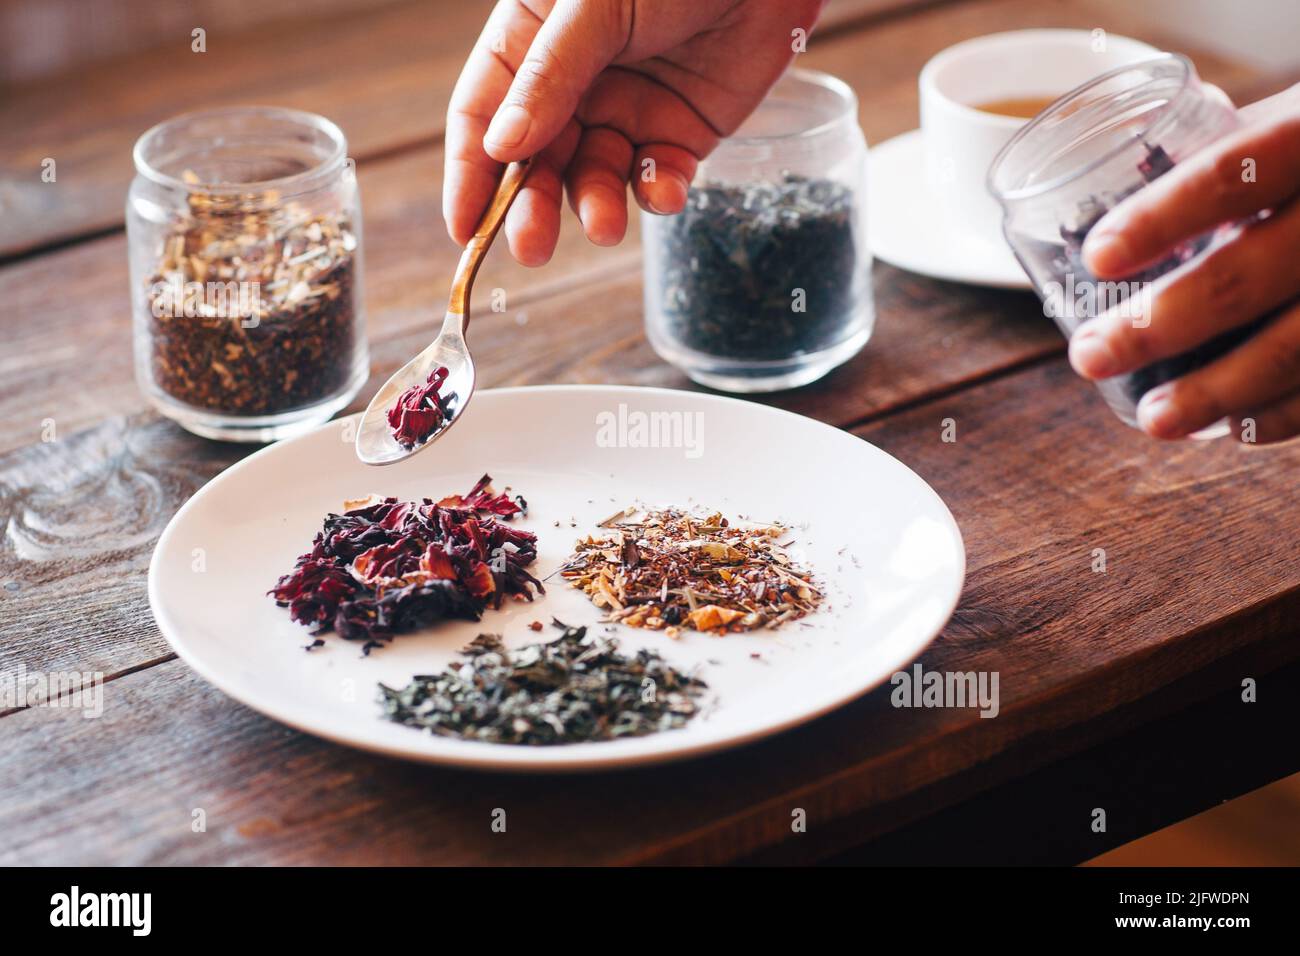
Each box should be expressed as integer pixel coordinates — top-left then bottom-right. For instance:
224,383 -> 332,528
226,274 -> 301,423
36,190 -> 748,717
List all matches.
659,174 -> 858,360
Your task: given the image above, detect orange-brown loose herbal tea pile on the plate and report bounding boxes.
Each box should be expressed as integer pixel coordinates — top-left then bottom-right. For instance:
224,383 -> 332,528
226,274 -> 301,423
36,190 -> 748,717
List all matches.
560,509 -> 822,637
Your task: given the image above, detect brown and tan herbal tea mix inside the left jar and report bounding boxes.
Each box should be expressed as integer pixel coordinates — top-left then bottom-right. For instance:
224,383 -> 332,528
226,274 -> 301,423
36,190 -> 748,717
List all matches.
144,180 -> 358,415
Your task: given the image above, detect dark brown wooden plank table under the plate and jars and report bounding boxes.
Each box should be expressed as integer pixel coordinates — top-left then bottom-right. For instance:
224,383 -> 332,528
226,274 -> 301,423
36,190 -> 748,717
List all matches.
0,0 -> 1300,864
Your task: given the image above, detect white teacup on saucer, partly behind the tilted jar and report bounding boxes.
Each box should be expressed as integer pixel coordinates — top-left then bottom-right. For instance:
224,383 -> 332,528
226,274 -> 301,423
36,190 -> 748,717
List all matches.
920,30 -> 1160,251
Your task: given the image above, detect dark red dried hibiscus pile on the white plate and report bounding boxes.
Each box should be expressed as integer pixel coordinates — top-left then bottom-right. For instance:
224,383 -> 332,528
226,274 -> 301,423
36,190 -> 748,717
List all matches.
268,475 -> 543,653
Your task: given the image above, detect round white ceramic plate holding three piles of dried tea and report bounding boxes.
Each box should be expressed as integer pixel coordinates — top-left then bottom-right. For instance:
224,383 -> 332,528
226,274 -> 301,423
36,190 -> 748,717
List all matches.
150,386 -> 966,770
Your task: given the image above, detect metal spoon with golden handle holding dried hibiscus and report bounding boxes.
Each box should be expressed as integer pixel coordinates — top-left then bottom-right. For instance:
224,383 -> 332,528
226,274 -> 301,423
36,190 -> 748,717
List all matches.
356,159 -> 532,464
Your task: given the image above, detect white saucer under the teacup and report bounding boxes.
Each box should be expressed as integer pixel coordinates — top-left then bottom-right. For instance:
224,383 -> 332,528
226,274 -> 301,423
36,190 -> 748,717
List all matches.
867,130 -> 1032,289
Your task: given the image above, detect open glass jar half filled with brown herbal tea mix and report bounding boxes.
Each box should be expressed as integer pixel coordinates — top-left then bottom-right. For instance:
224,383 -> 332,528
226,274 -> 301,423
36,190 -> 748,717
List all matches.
126,107 -> 369,441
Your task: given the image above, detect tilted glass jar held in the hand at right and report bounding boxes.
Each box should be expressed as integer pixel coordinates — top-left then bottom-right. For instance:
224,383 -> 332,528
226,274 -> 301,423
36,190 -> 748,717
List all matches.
988,53 -> 1256,438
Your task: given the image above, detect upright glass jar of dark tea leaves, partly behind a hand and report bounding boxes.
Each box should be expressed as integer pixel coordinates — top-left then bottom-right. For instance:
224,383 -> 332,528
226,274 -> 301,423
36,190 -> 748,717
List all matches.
641,70 -> 875,392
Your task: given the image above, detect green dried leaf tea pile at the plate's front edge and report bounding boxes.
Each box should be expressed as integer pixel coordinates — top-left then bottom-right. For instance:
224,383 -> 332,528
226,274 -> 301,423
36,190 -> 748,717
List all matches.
380,620 -> 707,747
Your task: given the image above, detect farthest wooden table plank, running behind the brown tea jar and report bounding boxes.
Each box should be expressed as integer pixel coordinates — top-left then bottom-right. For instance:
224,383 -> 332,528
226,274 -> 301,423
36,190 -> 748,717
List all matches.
0,0 -> 935,256
